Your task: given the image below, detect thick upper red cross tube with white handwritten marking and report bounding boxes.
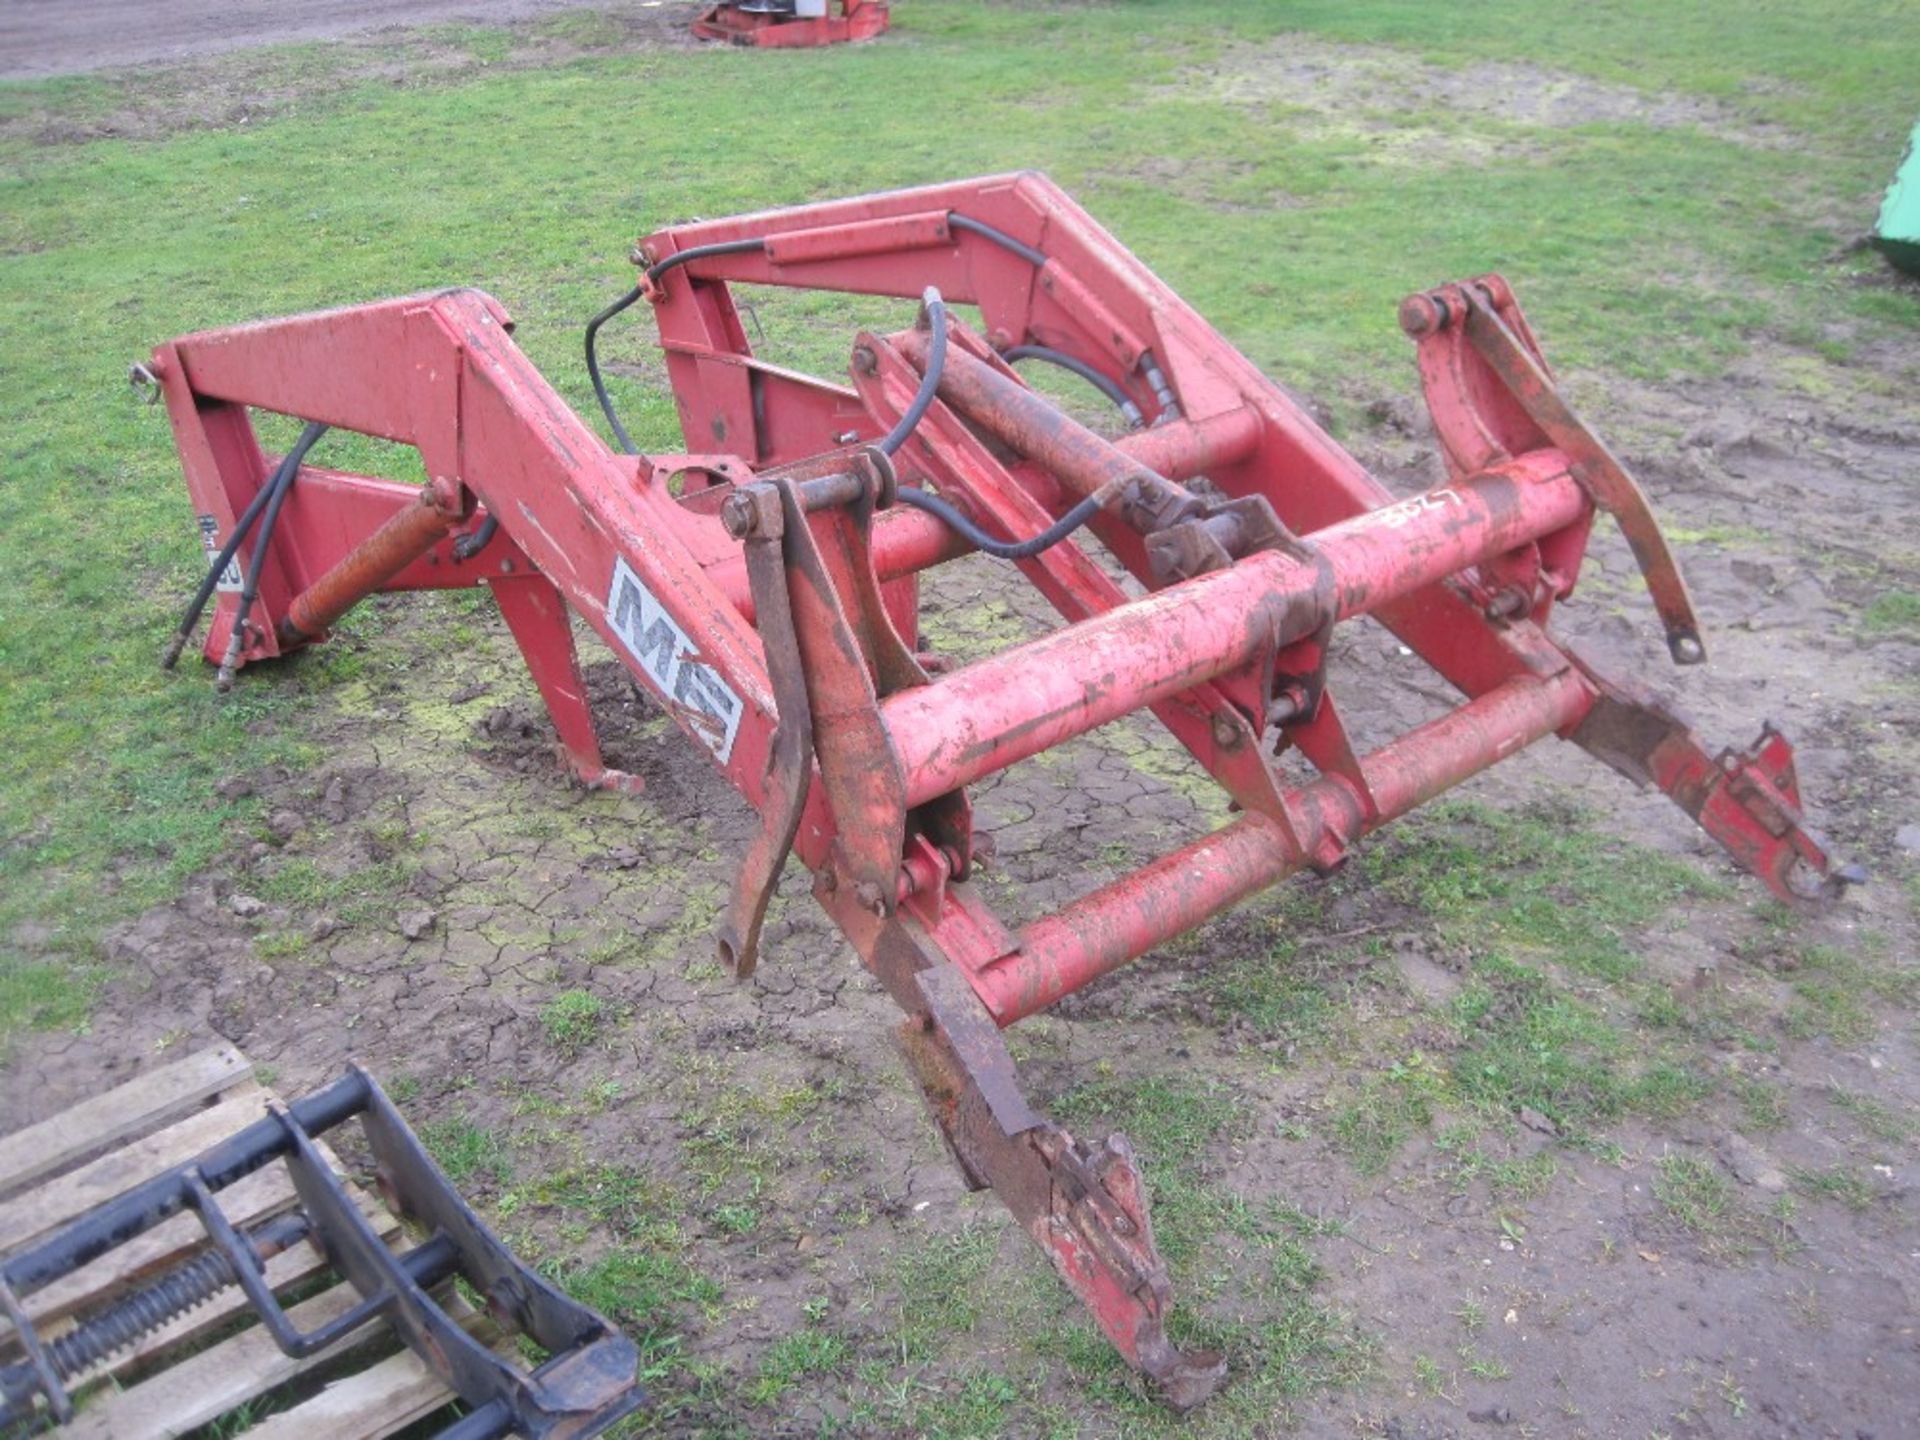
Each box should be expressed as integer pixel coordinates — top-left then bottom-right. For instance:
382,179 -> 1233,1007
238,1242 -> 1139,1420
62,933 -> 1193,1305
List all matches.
881,451 -> 1588,804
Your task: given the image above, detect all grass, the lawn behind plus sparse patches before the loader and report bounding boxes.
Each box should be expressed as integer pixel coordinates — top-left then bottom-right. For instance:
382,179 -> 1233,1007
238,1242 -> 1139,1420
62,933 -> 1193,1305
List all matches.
0,0 -> 1920,1434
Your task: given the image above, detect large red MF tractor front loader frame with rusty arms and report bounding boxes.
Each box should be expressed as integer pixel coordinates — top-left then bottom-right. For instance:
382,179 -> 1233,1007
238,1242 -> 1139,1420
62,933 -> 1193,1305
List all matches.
154,175 -> 1851,1405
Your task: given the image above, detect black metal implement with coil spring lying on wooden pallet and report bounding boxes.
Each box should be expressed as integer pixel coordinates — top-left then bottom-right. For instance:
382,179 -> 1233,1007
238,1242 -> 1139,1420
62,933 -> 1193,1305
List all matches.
0,1066 -> 645,1440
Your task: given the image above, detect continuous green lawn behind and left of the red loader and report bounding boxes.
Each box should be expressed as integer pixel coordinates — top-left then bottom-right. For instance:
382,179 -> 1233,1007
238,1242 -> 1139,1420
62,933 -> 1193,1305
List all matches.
0,0 -> 1920,1035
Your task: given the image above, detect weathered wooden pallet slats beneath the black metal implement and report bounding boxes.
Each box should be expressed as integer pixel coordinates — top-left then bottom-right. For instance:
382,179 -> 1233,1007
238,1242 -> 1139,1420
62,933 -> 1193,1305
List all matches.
0,1044 -> 482,1440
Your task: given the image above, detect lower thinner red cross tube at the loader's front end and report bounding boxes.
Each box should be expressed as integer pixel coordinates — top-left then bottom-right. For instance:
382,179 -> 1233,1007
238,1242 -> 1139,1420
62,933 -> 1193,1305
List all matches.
972,668 -> 1594,1025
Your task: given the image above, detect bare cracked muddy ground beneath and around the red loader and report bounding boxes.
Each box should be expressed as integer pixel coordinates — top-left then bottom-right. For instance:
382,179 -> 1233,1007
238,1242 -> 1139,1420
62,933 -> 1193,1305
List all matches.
0,4 -> 1920,1440
